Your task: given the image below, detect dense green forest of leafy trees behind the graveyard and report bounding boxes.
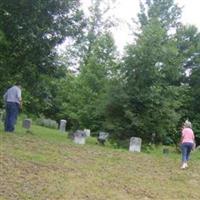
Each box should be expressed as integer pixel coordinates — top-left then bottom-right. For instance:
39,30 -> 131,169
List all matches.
0,0 -> 200,143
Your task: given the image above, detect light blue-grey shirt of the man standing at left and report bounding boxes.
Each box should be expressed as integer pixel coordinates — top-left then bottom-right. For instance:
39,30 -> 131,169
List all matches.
3,85 -> 22,104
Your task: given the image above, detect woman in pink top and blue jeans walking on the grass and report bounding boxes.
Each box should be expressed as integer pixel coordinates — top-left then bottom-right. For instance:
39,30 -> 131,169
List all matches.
181,120 -> 195,169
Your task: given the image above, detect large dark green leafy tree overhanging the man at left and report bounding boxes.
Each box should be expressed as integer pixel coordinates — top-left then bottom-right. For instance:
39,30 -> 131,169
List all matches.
0,0 -> 83,112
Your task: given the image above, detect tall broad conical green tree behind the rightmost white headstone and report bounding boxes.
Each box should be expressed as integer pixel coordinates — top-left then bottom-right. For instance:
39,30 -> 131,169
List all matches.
106,0 -> 184,142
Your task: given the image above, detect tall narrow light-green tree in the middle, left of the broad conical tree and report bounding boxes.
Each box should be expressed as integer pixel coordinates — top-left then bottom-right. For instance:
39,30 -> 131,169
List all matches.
54,0 -> 116,130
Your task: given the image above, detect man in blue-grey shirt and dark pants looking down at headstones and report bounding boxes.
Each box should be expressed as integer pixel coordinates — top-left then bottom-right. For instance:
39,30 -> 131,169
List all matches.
3,83 -> 22,132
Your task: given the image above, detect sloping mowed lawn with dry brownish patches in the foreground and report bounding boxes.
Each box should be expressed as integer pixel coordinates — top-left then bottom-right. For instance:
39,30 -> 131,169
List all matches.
0,123 -> 200,200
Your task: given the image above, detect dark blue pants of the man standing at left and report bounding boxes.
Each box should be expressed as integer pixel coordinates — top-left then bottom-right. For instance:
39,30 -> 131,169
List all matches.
5,102 -> 19,132
